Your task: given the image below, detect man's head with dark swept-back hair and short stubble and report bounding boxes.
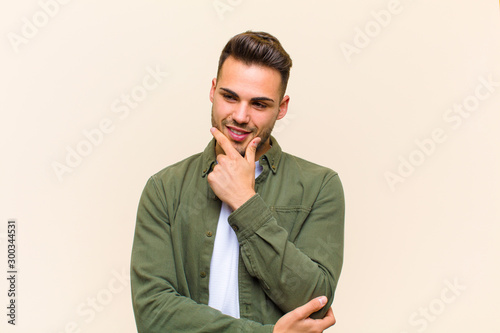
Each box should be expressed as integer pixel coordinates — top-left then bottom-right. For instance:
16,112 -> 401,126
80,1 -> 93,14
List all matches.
210,31 -> 292,158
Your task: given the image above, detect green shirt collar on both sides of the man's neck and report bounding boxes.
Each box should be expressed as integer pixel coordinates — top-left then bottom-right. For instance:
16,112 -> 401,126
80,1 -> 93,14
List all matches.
201,135 -> 282,177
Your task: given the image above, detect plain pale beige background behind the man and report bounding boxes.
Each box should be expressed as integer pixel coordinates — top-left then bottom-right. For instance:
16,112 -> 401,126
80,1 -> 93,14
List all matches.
0,0 -> 500,333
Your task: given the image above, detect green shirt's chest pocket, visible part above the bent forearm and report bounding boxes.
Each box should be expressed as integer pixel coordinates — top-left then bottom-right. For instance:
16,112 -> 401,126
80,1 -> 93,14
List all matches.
270,206 -> 311,243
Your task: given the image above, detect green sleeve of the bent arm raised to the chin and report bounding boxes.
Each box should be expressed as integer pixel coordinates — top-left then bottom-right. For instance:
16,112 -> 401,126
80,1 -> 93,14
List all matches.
228,173 -> 345,319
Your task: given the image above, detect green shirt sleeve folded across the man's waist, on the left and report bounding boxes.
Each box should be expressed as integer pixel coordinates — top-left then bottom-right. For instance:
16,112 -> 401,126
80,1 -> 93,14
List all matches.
131,177 -> 274,333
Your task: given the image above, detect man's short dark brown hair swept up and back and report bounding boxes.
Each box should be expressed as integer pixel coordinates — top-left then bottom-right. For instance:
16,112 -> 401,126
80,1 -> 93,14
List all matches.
217,31 -> 292,97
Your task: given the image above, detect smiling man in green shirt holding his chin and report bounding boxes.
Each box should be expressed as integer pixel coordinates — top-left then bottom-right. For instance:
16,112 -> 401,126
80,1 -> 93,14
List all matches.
131,32 -> 344,333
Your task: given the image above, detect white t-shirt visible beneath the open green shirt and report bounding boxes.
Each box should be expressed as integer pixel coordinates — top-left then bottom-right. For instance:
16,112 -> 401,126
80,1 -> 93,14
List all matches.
208,161 -> 262,318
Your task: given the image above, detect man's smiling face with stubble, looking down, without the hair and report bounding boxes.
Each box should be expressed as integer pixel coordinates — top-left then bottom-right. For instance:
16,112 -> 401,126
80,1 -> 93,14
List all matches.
210,57 -> 289,159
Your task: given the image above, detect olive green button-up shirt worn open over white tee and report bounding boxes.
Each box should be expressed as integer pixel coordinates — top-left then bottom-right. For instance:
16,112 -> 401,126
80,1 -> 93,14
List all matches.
131,137 -> 344,333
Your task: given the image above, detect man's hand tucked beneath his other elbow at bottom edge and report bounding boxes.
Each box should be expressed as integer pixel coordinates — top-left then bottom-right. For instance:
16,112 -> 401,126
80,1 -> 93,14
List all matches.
273,296 -> 336,333
